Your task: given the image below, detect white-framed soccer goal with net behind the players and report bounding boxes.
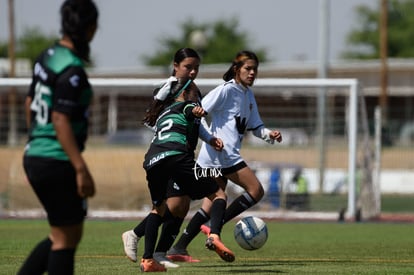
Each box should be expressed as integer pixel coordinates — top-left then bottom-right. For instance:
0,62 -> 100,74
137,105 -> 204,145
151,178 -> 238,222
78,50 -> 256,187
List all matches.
0,78 -> 380,218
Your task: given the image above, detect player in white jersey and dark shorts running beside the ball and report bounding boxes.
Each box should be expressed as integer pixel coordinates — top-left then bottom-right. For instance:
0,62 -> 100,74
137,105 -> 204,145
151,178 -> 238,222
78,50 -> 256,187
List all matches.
168,51 -> 282,261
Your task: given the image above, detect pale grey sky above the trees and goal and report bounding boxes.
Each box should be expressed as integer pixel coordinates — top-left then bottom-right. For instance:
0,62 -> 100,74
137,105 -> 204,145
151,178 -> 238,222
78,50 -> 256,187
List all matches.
0,0 -> 379,68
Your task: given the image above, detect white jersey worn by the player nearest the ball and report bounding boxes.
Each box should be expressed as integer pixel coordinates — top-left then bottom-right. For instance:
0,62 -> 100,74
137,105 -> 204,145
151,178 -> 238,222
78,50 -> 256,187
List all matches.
197,80 -> 270,168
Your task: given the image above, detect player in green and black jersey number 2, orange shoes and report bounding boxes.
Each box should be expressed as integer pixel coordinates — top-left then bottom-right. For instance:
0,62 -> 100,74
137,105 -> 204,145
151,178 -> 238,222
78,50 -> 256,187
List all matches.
137,77 -> 234,272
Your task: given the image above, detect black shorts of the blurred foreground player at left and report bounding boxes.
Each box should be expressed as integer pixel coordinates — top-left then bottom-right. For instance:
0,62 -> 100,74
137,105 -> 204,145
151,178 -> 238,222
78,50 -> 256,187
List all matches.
23,156 -> 87,226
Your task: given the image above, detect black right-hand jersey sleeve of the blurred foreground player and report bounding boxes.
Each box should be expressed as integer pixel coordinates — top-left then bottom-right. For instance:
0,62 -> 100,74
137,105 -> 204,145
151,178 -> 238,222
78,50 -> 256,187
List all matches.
53,66 -> 90,115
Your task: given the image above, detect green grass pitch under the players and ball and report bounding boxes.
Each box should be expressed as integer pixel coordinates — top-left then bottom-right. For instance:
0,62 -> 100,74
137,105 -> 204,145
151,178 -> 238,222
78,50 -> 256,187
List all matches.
0,219 -> 414,275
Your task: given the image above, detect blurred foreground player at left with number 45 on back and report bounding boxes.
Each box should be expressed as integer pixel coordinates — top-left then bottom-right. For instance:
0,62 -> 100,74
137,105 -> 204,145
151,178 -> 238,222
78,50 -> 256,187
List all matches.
18,0 -> 98,274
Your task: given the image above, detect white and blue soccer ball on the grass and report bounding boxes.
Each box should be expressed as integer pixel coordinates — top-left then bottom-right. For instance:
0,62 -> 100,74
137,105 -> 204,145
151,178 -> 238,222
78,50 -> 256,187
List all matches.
234,216 -> 268,250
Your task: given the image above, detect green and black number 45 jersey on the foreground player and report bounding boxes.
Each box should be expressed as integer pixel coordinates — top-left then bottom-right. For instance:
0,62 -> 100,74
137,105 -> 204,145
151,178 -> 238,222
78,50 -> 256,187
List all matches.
25,43 -> 93,160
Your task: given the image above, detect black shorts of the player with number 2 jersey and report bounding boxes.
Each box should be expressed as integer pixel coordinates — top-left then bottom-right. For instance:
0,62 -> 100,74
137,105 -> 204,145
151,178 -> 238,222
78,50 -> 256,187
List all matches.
147,154 -> 219,205
